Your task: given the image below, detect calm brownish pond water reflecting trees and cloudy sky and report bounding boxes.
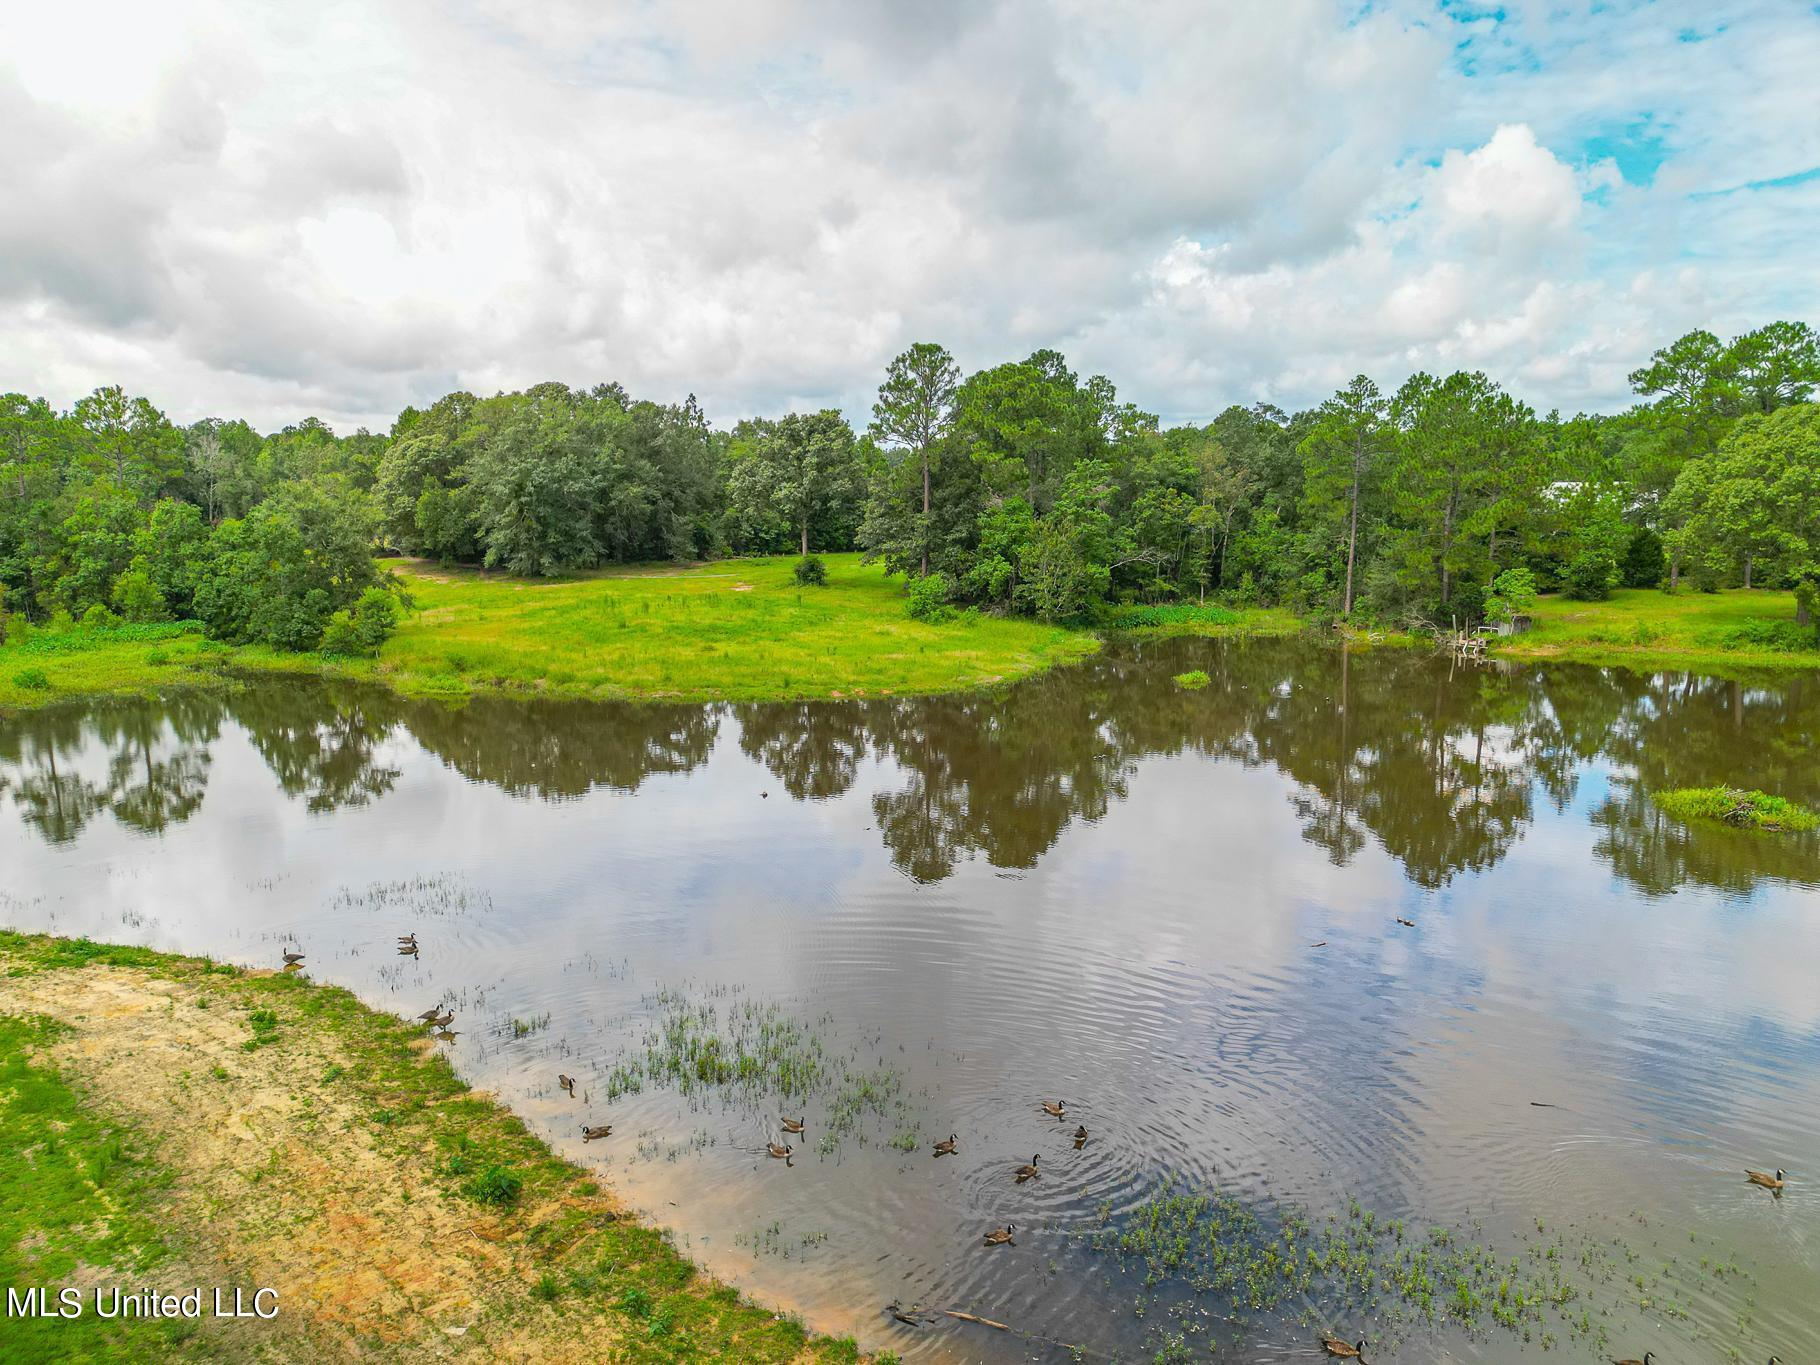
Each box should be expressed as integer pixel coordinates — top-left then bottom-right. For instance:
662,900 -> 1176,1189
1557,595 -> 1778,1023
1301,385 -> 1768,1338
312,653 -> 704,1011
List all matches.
0,641 -> 1820,1365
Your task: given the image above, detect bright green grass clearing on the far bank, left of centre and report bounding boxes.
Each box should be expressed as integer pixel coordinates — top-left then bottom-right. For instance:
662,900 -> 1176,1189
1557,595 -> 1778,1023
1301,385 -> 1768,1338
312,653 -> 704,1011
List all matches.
0,555 -> 1099,708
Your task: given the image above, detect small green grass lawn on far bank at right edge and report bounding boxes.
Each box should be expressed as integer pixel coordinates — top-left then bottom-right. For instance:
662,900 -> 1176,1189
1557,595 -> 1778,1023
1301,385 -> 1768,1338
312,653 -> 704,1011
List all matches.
1494,588 -> 1820,673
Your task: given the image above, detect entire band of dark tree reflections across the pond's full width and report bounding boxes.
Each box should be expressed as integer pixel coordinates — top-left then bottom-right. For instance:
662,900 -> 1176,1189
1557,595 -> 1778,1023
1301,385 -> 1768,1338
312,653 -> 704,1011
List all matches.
0,662 -> 1820,892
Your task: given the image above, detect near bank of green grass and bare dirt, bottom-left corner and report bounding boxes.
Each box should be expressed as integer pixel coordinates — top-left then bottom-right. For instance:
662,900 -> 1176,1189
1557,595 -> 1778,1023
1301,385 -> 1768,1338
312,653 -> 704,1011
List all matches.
0,932 -> 880,1365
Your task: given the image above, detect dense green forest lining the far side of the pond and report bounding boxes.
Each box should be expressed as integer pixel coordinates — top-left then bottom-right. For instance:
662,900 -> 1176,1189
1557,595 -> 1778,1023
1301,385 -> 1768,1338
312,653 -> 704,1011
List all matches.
0,322 -> 1820,652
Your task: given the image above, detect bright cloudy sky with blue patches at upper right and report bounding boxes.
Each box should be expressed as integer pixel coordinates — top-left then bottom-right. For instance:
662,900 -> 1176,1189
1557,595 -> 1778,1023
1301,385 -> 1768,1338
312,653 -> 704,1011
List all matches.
0,0 -> 1820,428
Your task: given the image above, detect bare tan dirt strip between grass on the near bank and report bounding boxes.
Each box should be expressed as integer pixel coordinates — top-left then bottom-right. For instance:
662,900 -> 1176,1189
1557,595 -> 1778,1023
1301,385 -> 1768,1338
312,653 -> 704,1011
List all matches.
0,966 -> 617,1361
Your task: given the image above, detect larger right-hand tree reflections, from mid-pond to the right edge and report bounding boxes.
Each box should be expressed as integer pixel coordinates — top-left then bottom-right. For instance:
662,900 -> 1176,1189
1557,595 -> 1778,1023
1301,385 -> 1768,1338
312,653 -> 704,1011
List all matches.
741,642 -> 1820,890
